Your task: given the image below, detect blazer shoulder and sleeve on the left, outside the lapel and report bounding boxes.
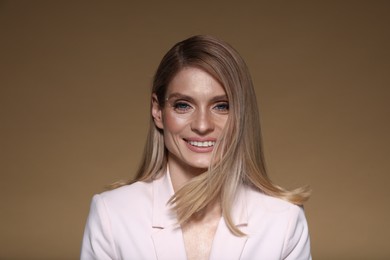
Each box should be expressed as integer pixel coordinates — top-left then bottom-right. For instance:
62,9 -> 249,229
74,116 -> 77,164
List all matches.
81,182 -> 158,259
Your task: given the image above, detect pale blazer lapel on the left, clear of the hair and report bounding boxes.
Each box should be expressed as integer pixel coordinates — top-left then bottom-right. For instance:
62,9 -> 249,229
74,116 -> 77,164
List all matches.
152,172 -> 186,260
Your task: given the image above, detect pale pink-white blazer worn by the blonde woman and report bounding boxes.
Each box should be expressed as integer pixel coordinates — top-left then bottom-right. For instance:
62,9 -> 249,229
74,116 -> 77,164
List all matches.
81,173 -> 311,260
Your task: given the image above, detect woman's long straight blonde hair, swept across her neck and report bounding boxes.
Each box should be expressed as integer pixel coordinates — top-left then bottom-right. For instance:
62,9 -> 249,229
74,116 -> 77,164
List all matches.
125,35 -> 310,236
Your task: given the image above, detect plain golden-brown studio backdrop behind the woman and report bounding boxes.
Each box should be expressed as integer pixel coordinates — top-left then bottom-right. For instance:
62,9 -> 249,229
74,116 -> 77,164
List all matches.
0,1 -> 390,259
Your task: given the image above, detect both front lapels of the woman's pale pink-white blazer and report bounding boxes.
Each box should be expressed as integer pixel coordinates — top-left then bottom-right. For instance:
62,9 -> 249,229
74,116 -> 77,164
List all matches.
152,170 -> 248,260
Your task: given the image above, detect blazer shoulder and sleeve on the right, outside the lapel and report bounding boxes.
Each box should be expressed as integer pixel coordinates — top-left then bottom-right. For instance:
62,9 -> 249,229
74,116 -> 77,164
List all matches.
241,187 -> 311,259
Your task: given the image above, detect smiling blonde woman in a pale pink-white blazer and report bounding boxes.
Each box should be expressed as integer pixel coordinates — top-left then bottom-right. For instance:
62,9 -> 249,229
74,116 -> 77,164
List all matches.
81,36 -> 311,259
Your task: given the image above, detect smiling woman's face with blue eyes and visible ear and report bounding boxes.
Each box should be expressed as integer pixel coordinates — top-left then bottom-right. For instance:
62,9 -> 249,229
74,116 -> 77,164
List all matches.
152,67 -> 229,172
